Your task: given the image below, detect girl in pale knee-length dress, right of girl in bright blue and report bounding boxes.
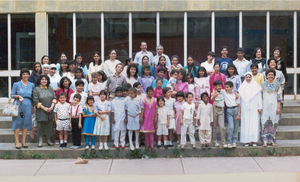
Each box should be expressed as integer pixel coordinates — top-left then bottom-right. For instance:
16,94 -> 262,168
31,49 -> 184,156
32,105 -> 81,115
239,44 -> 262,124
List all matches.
93,90 -> 111,150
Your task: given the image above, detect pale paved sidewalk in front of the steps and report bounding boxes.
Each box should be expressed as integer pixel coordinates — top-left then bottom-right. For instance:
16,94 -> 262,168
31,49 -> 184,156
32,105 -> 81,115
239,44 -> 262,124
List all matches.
0,156 -> 300,182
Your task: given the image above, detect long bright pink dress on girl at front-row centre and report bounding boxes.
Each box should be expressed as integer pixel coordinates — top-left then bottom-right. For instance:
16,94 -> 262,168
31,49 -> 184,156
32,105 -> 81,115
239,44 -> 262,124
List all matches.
140,97 -> 156,133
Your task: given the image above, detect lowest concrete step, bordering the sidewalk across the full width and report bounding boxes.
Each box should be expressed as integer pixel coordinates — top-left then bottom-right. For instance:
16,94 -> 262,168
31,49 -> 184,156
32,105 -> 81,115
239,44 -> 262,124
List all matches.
0,140 -> 300,159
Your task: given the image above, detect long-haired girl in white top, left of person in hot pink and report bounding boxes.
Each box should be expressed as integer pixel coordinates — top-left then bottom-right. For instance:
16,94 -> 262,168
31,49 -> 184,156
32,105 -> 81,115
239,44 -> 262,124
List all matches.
194,66 -> 210,101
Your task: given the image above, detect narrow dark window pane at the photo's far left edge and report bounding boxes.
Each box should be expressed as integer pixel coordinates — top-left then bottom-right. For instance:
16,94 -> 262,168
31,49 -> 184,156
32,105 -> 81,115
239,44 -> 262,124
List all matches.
0,15 -> 8,70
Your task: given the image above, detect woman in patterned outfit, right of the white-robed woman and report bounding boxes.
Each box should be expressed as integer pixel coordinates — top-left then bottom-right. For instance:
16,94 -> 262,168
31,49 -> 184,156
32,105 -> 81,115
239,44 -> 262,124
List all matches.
261,68 -> 281,147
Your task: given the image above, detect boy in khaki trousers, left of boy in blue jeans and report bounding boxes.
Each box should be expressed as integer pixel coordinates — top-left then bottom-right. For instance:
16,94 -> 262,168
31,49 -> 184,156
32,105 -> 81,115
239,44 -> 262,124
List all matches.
211,80 -> 227,148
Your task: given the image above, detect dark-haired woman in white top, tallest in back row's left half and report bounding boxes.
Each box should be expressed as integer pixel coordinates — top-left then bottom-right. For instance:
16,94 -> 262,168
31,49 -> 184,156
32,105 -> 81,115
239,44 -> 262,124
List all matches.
101,49 -> 121,77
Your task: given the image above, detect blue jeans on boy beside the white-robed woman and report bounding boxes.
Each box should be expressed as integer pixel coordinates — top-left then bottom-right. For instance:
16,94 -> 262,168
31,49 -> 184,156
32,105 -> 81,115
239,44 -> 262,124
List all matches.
227,107 -> 239,144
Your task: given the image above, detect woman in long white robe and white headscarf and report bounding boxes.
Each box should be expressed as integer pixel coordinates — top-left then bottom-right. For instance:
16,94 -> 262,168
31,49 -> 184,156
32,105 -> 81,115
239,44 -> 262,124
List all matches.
237,72 -> 262,147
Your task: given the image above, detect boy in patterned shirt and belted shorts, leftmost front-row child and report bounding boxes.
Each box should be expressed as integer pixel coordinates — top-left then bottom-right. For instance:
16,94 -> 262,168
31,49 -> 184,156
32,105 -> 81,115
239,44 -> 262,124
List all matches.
53,92 -> 70,148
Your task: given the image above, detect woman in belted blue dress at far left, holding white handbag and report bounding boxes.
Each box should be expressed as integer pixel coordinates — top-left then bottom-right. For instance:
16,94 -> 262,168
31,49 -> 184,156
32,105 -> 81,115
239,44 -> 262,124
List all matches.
10,68 -> 35,149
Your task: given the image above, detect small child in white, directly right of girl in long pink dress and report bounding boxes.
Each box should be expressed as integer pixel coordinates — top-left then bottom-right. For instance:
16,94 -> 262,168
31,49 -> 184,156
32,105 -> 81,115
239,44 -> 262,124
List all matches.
155,97 -> 171,149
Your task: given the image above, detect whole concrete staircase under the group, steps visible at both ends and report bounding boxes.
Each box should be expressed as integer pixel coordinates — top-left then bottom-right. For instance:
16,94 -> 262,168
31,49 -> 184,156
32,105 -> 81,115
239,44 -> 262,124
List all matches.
0,100 -> 300,158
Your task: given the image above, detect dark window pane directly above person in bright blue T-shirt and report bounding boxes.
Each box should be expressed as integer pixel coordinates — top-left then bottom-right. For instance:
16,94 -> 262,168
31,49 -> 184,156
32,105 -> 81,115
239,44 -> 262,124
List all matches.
215,12 -> 239,60
